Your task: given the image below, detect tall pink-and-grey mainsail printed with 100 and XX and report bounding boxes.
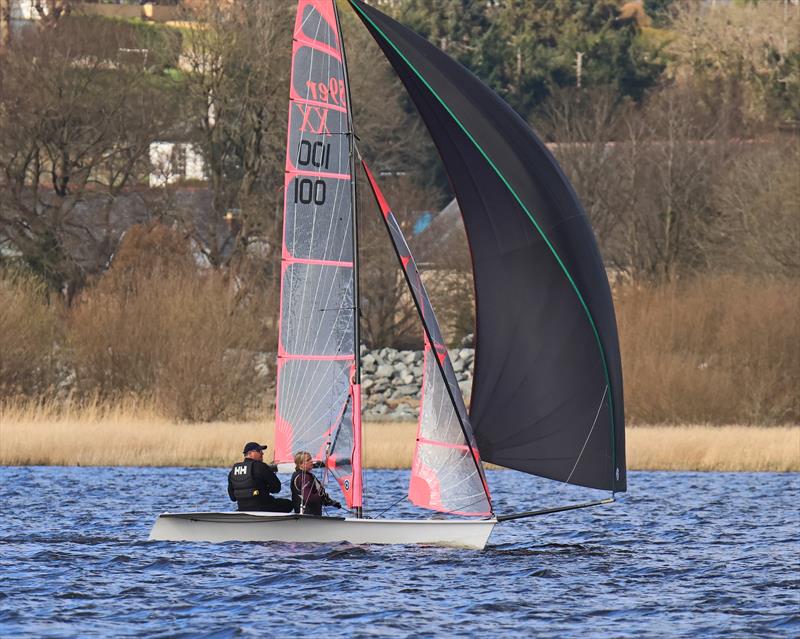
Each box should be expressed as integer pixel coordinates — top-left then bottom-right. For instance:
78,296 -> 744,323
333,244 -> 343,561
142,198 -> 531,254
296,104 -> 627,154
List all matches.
275,0 -> 362,508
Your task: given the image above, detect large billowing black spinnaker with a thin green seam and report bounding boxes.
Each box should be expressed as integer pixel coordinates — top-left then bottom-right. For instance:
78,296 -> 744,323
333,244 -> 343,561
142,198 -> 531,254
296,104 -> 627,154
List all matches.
349,0 -> 626,491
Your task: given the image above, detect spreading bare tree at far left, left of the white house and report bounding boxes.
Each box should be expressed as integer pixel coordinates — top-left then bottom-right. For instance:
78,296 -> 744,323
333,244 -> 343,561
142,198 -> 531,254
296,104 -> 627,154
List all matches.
0,18 -> 180,300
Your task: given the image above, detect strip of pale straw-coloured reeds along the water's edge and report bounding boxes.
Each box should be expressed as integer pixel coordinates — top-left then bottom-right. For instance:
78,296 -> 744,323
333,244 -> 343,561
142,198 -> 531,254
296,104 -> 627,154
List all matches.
0,405 -> 800,472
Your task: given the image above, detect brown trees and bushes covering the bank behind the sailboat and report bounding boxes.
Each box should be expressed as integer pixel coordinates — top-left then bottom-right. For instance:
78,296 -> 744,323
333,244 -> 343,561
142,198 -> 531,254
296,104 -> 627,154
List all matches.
0,0 -> 800,424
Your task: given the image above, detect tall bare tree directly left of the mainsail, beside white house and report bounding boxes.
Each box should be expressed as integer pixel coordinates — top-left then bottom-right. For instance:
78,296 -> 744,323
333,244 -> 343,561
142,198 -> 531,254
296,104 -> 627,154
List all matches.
177,0 -> 293,265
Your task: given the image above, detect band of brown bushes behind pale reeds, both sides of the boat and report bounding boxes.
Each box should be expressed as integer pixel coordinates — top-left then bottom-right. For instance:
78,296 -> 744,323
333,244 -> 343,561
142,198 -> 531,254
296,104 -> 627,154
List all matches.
0,268 -> 800,425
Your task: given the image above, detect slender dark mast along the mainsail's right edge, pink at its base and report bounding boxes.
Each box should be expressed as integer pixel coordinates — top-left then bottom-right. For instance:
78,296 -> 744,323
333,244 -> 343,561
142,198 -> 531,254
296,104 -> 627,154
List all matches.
332,0 -> 363,519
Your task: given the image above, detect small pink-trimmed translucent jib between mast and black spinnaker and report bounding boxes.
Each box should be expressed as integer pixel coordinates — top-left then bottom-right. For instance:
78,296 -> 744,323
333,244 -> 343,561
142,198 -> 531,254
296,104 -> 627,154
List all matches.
362,162 -> 492,516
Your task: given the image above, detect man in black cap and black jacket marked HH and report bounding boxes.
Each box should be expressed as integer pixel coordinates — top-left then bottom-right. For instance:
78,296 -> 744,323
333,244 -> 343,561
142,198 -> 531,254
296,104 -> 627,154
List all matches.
228,442 -> 293,513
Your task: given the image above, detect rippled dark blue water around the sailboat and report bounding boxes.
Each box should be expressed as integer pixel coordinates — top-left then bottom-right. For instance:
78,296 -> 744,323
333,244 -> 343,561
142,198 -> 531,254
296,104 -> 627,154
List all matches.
0,468 -> 800,637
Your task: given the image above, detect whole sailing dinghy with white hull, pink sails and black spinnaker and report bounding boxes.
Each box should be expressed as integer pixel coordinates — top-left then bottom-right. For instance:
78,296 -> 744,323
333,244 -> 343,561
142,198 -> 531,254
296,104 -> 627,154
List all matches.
150,0 -> 626,549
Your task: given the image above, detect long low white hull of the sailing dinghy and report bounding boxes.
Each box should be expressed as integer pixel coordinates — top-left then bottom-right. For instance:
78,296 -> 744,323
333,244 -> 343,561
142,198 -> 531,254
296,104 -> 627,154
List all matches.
150,512 -> 490,550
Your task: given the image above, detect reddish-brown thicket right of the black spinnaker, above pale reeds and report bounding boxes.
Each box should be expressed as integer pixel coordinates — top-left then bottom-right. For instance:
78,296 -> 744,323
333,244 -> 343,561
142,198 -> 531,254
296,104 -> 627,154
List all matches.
616,276 -> 800,425
